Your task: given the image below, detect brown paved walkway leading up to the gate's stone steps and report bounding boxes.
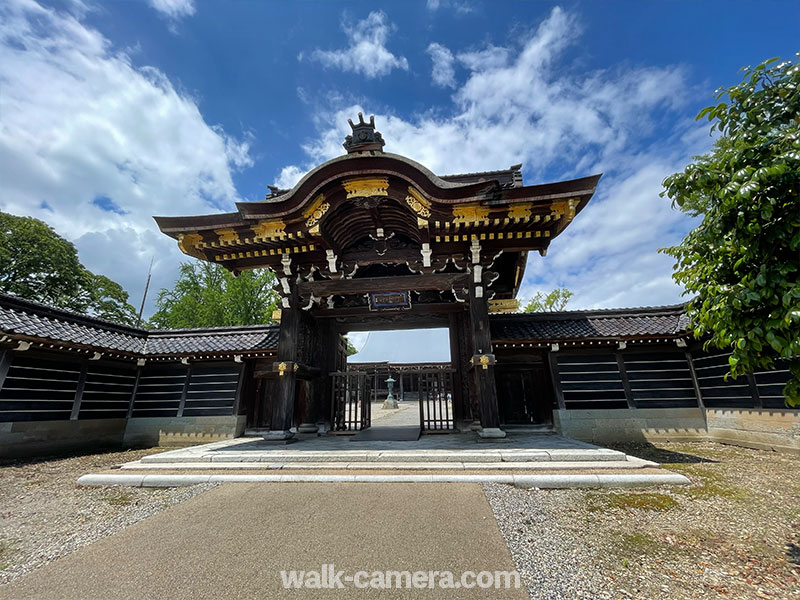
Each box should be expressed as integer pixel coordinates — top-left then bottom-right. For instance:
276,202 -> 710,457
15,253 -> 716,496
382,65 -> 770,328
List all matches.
0,484 -> 527,600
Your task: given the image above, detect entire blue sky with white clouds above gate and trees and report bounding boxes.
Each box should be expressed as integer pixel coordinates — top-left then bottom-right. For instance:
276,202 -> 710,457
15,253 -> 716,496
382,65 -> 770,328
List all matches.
0,0 -> 800,332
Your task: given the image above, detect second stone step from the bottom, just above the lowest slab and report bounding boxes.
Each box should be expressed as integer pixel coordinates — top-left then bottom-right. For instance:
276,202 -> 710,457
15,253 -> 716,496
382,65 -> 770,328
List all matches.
120,457 -> 659,472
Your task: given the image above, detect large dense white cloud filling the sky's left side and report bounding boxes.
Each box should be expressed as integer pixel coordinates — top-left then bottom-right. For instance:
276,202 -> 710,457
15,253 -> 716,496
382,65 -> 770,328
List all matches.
0,0 -> 252,316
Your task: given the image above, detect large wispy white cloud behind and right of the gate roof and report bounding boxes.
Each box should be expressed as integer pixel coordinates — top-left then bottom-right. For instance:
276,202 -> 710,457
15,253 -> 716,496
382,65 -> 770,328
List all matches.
282,8 -> 709,308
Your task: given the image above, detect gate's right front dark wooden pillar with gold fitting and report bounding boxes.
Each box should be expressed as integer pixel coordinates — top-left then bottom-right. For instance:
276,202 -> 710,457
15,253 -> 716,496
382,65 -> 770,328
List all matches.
469,277 -> 506,438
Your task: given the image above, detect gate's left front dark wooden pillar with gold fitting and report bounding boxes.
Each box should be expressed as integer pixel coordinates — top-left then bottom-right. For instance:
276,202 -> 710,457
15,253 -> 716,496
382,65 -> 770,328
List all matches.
272,282 -> 300,440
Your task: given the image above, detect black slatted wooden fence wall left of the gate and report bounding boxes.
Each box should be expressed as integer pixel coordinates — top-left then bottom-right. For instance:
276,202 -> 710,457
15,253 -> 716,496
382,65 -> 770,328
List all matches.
0,351 -> 242,422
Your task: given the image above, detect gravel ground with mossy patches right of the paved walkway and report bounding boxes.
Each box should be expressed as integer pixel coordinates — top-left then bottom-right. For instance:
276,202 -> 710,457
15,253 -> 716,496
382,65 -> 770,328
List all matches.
484,442 -> 800,600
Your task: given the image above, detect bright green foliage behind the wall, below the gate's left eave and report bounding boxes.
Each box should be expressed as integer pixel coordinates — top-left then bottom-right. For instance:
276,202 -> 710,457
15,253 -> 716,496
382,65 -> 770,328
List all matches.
150,261 -> 278,329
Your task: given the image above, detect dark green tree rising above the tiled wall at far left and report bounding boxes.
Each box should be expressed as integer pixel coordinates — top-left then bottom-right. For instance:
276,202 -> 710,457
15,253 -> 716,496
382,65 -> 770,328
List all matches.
0,212 -> 136,325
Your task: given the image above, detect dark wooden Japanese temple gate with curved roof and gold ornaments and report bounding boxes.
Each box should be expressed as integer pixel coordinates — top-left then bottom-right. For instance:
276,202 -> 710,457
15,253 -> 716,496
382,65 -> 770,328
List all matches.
156,114 -> 600,439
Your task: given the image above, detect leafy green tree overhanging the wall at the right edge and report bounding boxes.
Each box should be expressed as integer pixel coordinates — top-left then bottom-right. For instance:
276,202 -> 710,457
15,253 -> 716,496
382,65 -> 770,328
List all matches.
662,54 -> 800,405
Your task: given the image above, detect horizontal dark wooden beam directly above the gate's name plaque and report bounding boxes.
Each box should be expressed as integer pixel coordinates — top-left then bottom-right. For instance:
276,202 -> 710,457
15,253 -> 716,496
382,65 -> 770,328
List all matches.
297,273 -> 469,298
